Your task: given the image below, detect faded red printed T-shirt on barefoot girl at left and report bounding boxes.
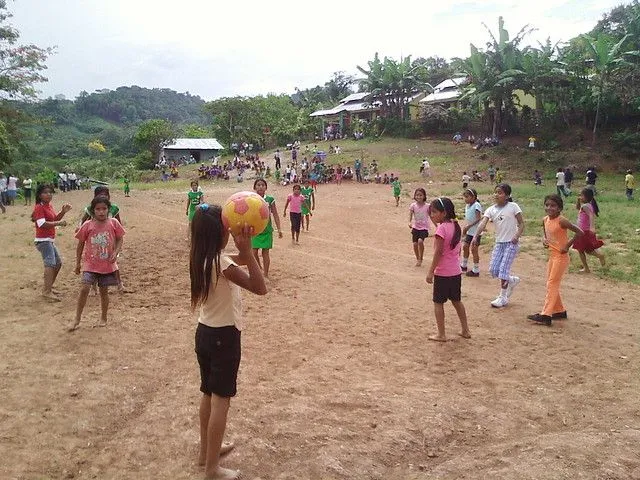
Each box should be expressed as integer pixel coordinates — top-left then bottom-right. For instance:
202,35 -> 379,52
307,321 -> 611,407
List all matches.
76,218 -> 124,273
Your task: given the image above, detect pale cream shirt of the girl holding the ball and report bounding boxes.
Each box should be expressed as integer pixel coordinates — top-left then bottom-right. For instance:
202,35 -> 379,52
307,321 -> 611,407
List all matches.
198,253 -> 242,330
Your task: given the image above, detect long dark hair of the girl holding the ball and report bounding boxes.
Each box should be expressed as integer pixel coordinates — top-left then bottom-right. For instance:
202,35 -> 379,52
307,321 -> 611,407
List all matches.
189,203 -> 225,310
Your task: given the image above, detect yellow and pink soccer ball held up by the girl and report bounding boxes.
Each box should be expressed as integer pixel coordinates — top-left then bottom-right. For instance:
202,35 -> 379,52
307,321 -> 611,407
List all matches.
222,192 -> 269,235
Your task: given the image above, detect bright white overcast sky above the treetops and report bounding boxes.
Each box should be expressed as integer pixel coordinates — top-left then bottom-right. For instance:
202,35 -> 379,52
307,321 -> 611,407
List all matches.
8,0 -> 621,100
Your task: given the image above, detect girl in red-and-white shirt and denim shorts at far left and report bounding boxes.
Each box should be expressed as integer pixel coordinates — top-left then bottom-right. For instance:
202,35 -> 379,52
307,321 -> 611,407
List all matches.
31,184 -> 71,302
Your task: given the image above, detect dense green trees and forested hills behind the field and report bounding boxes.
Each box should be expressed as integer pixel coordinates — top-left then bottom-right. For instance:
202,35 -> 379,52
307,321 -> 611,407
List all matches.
0,0 -> 640,177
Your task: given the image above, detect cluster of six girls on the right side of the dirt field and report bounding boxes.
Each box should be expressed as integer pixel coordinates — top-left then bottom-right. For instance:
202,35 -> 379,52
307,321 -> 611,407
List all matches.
409,183 -> 605,341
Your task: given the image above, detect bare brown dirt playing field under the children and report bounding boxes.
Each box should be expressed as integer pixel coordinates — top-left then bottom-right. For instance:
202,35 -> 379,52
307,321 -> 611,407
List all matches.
0,182 -> 640,480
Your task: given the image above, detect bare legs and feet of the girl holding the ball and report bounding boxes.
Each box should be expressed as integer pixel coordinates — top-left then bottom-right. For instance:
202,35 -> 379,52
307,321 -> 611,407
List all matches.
199,394 -> 240,480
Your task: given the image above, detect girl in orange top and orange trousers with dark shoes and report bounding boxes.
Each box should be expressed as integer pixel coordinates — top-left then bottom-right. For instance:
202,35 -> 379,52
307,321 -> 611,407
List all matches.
527,195 -> 582,326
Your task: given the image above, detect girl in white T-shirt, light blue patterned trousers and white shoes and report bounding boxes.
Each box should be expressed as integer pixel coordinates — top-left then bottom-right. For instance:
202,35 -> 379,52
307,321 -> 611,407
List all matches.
472,183 -> 524,308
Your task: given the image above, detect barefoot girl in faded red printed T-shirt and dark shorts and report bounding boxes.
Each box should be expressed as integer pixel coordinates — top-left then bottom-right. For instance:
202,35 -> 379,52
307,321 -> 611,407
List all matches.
68,197 -> 125,332
